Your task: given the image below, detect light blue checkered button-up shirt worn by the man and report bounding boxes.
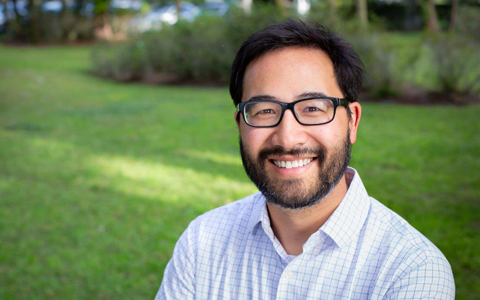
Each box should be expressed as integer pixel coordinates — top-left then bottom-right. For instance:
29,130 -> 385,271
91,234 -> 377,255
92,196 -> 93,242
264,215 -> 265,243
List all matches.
155,169 -> 455,300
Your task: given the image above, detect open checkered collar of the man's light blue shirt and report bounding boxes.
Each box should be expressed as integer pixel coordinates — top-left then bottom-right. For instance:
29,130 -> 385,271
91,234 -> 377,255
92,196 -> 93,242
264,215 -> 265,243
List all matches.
248,167 -> 370,248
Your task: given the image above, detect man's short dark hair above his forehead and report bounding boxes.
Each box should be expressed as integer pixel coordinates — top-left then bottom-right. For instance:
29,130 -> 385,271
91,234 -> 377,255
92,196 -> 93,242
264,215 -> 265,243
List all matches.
230,19 -> 363,105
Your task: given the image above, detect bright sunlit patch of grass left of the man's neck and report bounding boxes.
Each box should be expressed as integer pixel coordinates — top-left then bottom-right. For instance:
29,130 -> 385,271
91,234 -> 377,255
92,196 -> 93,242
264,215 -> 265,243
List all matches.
89,154 -> 255,207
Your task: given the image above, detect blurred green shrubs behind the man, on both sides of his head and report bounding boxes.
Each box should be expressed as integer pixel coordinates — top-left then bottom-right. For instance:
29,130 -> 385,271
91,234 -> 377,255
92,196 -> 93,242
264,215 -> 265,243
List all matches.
92,4 -> 480,104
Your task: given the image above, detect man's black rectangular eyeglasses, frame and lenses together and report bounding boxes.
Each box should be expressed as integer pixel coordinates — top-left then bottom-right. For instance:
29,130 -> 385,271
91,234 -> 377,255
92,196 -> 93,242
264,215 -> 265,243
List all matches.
237,97 -> 350,127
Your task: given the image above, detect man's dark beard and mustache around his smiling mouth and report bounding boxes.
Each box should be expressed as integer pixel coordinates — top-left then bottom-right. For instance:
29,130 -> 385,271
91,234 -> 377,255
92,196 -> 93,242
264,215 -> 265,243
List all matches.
240,131 -> 351,209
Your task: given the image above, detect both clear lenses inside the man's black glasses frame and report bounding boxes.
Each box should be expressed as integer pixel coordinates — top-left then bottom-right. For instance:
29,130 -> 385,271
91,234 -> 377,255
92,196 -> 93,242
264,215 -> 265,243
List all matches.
244,99 -> 335,126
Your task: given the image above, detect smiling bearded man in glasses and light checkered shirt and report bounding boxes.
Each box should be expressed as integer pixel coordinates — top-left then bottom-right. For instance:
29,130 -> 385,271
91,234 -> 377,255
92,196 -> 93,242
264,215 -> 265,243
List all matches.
156,20 -> 455,299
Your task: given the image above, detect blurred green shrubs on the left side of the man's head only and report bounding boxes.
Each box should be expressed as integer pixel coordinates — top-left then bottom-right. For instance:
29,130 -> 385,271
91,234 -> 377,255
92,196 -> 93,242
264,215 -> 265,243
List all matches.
92,6 -> 292,84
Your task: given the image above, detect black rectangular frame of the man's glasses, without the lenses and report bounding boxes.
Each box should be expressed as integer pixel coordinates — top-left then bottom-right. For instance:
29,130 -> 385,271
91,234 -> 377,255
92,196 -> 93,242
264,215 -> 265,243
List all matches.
236,96 -> 352,128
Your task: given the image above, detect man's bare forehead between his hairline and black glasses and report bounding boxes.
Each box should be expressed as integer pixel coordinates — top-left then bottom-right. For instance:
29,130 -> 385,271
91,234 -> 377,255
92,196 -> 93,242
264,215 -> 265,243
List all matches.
242,48 -> 343,102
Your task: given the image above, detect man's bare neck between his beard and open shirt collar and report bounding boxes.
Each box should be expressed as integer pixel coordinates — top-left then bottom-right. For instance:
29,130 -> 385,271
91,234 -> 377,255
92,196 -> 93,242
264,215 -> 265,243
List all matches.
267,175 -> 348,255
